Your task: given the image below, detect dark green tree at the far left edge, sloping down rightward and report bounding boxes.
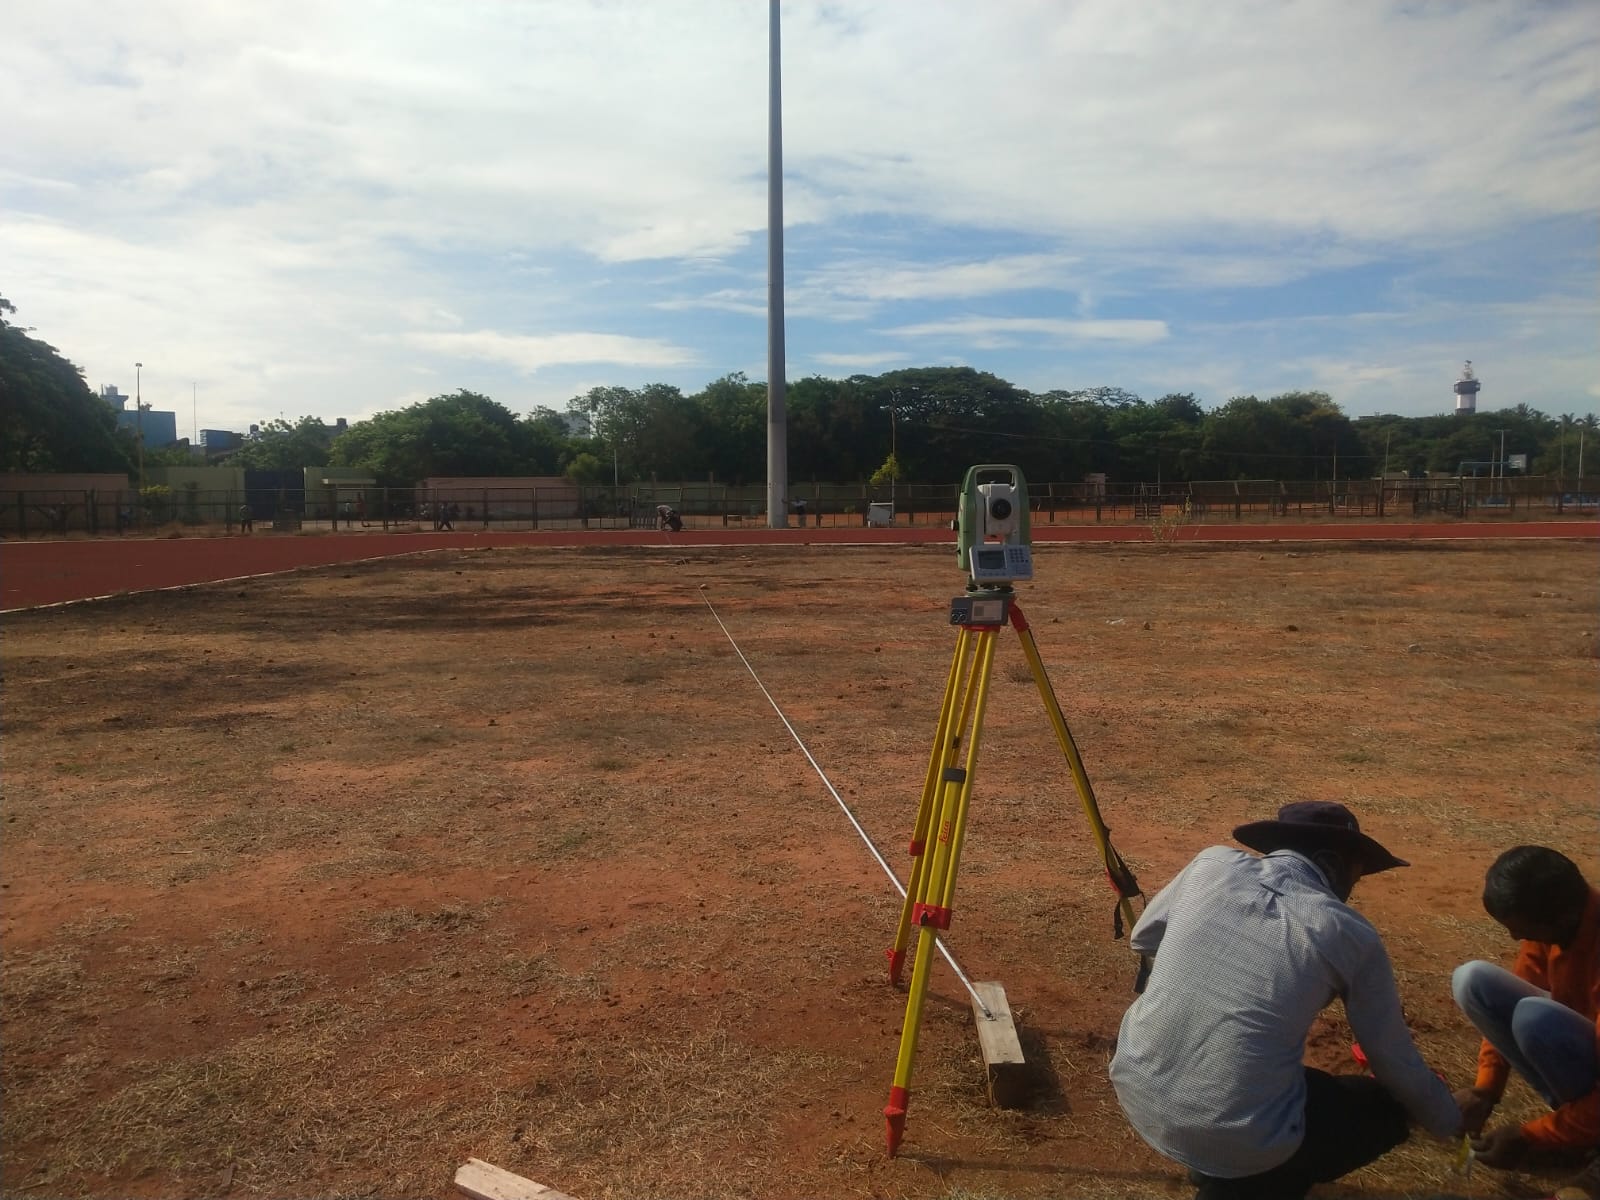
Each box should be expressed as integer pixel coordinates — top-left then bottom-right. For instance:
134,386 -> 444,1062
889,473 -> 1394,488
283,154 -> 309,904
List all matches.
0,296 -> 136,472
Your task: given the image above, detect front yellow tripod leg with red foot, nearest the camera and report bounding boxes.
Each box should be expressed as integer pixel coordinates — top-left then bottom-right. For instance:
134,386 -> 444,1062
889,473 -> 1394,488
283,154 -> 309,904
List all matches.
883,629 -> 995,1155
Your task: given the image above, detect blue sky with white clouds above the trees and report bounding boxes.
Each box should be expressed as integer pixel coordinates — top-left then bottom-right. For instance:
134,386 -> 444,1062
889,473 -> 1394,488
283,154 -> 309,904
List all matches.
0,0 -> 1600,435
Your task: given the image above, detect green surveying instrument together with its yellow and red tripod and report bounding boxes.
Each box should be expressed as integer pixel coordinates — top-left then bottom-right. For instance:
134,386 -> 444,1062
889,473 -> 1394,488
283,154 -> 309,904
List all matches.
883,464 -> 1149,1155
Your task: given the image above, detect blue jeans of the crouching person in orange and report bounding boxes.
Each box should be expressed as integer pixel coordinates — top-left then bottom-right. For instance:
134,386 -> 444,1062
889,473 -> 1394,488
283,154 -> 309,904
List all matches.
1450,962 -> 1600,1109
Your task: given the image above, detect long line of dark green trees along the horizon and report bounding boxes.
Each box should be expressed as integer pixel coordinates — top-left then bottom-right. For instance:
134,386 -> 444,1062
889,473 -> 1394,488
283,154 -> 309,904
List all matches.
0,298 -> 1600,486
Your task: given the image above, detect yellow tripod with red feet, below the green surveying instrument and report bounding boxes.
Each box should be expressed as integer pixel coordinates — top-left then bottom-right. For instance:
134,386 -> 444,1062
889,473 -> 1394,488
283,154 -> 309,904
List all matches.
883,587 -> 1149,1155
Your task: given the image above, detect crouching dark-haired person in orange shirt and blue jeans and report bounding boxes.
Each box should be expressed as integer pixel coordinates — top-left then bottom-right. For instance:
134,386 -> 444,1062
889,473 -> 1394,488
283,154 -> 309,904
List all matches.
1450,846 -> 1600,1170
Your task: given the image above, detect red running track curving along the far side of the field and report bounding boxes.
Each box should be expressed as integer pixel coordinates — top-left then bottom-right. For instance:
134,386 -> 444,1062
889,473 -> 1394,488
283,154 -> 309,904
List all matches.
0,518 -> 1600,613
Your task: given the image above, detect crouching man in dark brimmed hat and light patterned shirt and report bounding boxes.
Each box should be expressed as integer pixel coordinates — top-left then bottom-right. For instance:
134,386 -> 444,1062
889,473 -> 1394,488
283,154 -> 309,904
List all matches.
1110,802 -> 1461,1200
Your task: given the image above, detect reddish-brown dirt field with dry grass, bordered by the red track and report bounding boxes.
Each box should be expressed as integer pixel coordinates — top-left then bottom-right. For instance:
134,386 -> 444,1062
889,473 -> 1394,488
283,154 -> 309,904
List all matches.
0,542 -> 1600,1200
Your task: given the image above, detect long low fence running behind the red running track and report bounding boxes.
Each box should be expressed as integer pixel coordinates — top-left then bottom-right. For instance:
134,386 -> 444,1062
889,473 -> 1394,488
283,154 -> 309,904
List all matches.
0,477 -> 1600,538
